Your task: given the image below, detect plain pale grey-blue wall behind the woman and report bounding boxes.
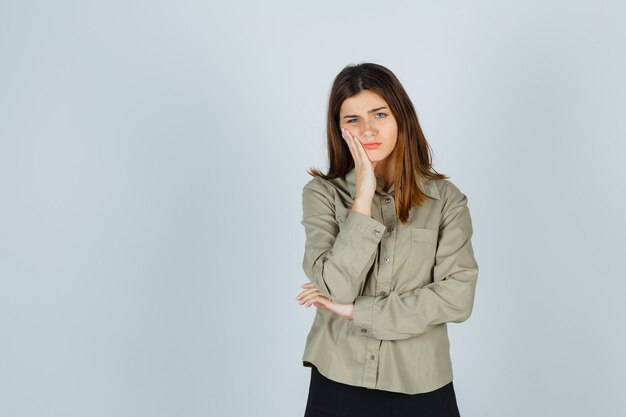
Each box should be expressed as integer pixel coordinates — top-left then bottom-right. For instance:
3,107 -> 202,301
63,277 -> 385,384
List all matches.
0,0 -> 626,417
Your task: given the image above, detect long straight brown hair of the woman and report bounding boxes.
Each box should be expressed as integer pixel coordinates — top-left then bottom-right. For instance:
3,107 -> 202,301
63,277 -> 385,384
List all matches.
308,62 -> 449,223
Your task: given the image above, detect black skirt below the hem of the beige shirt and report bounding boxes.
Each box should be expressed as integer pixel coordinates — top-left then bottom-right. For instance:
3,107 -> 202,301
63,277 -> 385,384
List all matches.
304,366 -> 460,417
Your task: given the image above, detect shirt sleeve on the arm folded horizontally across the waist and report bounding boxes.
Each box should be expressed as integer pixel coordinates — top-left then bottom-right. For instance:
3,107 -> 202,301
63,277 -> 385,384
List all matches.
353,182 -> 478,340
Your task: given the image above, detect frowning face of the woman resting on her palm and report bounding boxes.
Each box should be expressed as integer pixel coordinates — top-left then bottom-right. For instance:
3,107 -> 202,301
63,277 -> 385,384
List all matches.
339,90 -> 398,162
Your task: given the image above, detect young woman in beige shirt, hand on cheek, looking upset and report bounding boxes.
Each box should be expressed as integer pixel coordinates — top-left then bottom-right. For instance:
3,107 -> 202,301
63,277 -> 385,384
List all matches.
296,63 -> 478,417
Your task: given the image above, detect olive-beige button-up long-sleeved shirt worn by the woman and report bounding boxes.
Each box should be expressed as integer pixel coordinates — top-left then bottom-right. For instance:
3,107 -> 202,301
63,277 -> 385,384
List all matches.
301,168 -> 478,394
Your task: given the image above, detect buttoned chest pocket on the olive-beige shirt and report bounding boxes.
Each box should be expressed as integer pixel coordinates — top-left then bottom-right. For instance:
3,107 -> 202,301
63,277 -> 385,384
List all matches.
407,227 -> 439,286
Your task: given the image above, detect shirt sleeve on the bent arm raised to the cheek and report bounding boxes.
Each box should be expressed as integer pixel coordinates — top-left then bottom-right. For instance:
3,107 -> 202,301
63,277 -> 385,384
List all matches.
301,177 -> 385,304
